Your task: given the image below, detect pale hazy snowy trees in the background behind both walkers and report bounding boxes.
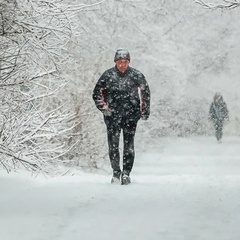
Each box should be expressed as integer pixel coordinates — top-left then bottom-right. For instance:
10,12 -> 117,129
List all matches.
66,0 -> 240,160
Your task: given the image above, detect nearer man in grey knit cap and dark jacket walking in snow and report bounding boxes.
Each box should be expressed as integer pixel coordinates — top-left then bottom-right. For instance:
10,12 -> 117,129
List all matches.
92,49 -> 150,185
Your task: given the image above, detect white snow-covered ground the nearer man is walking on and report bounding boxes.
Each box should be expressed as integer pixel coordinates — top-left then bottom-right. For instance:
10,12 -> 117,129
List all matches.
0,136 -> 240,240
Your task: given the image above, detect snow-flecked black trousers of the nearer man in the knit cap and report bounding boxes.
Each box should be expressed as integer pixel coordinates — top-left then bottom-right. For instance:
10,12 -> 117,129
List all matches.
105,117 -> 138,175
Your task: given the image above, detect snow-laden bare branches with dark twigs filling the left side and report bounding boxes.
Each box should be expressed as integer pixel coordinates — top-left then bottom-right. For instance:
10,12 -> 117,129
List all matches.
0,0 -> 99,171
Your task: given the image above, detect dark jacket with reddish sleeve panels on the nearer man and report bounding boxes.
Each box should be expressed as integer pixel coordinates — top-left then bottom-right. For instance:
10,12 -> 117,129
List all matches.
92,66 -> 150,120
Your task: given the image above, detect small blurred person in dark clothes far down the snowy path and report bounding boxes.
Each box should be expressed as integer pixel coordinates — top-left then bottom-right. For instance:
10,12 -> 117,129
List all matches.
209,93 -> 229,142
